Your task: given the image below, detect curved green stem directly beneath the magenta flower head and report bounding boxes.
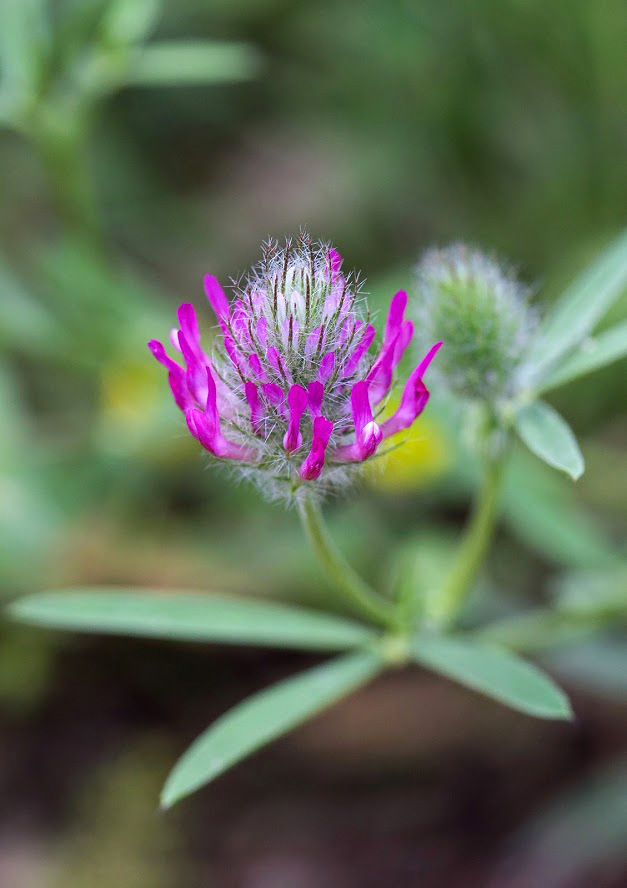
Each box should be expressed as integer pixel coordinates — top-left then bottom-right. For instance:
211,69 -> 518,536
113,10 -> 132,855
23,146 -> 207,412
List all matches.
298,496 -> 395,627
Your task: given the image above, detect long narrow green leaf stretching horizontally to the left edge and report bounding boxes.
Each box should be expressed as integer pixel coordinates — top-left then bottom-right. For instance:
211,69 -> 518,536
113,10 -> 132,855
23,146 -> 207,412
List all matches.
9,588 -> 375,651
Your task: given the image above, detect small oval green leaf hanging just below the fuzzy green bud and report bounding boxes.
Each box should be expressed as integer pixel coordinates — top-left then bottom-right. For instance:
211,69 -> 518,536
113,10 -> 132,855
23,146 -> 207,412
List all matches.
514,401 -> 584,481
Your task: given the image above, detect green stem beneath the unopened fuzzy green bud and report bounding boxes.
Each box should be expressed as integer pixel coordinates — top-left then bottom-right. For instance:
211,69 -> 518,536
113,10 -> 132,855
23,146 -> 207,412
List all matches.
432,452 -> 505,624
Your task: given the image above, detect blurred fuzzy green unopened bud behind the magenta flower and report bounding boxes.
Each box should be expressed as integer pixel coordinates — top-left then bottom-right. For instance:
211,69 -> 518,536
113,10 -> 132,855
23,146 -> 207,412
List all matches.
416,244 -> 535,402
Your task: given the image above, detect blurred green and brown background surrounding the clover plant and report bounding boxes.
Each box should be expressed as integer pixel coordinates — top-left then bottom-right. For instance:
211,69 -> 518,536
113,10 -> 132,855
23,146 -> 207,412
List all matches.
0,0 -> 627,888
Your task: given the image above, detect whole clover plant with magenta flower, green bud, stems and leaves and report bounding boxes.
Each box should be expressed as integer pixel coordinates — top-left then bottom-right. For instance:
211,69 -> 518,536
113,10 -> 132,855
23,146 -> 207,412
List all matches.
11,234 -> 627,807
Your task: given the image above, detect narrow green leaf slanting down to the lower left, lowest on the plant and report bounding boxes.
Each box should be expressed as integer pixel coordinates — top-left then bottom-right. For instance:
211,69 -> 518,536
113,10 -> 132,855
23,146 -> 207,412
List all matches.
161,653 -> 382,808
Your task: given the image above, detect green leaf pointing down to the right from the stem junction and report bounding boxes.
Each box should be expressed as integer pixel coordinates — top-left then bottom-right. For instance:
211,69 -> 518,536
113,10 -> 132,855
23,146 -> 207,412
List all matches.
412,636 -> 572,719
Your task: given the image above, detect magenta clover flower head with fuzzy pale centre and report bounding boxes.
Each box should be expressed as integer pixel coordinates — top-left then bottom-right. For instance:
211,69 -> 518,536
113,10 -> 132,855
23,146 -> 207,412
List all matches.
149,235 -> 442,495
